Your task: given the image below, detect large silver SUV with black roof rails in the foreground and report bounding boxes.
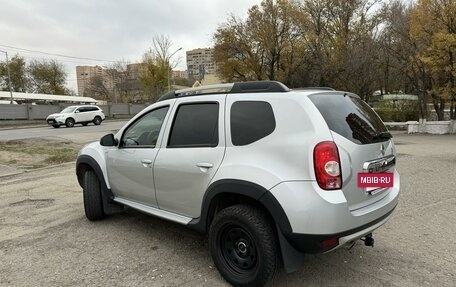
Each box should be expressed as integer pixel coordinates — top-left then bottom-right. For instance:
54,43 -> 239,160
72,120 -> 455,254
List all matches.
76,81 -> 400,286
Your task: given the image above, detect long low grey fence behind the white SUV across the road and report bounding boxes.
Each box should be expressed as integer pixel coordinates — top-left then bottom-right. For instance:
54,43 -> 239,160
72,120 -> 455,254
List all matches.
0,104 -> 147,120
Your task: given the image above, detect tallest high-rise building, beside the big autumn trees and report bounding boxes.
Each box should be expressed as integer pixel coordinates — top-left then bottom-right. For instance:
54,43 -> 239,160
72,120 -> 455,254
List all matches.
187,48 -> 216,80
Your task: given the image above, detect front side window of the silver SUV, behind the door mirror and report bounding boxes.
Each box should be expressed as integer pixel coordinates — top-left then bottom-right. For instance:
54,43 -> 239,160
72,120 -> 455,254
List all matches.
121,106 -> 169,147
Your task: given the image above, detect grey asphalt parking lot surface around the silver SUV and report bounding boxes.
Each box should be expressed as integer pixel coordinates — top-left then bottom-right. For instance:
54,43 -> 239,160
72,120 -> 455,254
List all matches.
0,128 -> 456,286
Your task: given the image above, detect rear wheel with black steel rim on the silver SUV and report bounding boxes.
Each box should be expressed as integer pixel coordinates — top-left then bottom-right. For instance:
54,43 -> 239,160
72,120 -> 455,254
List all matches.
209,205 -> 279,286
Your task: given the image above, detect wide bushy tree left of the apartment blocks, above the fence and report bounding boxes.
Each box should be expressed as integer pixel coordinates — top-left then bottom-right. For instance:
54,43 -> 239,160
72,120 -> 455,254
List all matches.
28,60 -> 67,95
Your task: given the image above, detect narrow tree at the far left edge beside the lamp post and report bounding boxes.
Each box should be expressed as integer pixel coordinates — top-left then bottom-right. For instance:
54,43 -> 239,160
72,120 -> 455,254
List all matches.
0,54 -> 30,93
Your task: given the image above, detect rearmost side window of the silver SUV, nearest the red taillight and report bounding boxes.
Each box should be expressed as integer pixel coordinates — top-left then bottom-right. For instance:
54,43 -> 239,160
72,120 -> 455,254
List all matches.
230,101 -> 276,146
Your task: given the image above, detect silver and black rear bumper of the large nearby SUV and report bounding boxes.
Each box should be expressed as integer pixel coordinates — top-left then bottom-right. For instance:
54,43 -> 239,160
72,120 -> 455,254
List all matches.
270,172 -> 400,253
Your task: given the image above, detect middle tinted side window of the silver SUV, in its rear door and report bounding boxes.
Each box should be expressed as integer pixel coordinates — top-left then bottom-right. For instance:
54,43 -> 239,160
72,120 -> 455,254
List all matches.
168,103 -> 219,148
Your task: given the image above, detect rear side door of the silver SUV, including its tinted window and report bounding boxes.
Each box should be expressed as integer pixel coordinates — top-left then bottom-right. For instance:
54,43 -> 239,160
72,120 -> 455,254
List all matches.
154,95 -> 226,218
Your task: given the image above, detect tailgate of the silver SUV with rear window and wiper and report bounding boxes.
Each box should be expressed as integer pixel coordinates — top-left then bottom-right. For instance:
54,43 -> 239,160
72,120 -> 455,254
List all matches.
309,93 -> 396,210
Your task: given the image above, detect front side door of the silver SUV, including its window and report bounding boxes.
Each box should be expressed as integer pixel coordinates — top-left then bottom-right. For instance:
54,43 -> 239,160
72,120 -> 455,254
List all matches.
107,106 -> 169,207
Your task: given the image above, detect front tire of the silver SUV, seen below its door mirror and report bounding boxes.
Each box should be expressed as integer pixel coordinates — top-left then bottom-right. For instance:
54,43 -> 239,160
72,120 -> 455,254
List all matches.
83,170 -> 105,221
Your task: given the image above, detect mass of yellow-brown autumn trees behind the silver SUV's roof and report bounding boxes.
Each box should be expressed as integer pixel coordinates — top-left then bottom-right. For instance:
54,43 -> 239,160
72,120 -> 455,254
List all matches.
214,0 -> 456,119
